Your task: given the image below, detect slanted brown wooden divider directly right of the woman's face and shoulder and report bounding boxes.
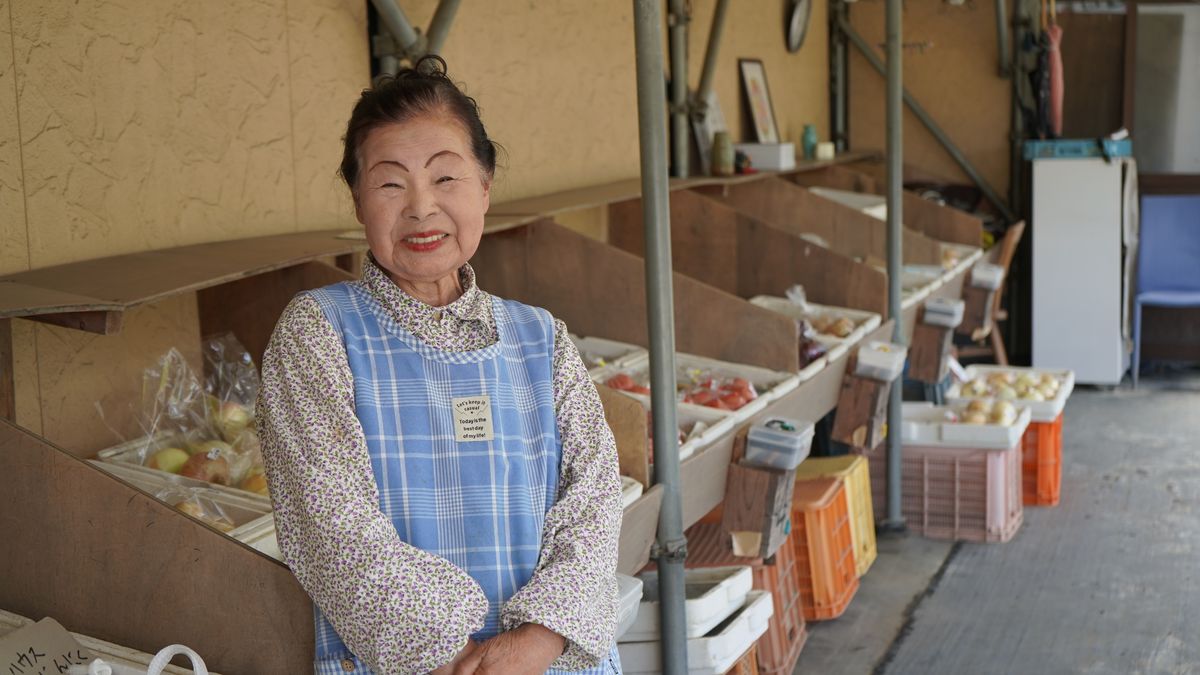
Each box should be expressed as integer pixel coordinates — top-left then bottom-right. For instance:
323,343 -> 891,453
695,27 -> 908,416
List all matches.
472,221 -> 799,372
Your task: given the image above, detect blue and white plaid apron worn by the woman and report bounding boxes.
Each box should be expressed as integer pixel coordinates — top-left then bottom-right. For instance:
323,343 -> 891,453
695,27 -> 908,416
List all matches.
310,283 -> 620,675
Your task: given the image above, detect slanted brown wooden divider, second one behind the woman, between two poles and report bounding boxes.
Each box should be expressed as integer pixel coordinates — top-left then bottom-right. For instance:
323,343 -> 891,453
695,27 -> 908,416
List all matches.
608,191 -> 887,312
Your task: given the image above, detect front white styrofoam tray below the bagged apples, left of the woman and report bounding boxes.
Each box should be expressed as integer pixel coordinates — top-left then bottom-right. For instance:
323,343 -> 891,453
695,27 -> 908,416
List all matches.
89,460 -> 283,560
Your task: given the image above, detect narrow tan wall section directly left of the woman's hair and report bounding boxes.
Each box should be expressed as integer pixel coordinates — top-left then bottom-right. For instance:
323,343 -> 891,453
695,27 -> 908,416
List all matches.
286,0 -> 364,229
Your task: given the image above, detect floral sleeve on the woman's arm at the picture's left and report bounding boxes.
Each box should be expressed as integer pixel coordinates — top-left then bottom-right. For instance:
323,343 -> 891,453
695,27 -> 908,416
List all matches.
257,297 -> 487,673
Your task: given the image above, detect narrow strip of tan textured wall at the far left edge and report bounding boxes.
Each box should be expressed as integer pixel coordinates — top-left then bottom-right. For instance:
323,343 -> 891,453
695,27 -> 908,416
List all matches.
0,0 -> 29,274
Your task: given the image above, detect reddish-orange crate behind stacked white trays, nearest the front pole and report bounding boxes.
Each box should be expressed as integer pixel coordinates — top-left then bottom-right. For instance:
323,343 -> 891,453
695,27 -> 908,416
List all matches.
686,522 -> 809,675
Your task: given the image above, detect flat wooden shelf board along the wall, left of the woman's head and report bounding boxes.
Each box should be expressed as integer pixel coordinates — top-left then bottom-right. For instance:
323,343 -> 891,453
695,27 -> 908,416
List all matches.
0,231 -> 366,329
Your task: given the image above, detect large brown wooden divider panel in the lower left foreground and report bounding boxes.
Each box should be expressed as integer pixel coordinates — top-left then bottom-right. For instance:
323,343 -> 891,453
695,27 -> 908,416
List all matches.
0,422 -> 313,673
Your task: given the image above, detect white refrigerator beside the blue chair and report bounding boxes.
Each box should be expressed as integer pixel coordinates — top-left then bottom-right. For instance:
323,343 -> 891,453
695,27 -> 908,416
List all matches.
1031,157 -> 1138,386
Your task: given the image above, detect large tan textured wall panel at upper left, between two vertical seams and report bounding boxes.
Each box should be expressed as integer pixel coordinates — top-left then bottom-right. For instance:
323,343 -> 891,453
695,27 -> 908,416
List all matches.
12,0 -> 295,268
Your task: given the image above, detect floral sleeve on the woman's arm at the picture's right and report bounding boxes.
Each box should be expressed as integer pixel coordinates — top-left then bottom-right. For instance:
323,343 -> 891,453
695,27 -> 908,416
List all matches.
502,321 -> 622,670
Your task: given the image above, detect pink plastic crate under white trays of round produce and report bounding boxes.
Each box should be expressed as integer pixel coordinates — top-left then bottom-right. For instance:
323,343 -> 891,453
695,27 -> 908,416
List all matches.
866,442 -> 1025,542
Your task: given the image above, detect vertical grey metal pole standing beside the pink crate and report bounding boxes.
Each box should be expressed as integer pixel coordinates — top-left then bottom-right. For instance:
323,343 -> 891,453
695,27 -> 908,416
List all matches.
886,0 -> 904,528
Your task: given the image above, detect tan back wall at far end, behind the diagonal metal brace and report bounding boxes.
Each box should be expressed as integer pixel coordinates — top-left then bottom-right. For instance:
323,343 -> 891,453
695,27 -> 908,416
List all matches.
850,0 -> 1010,198
